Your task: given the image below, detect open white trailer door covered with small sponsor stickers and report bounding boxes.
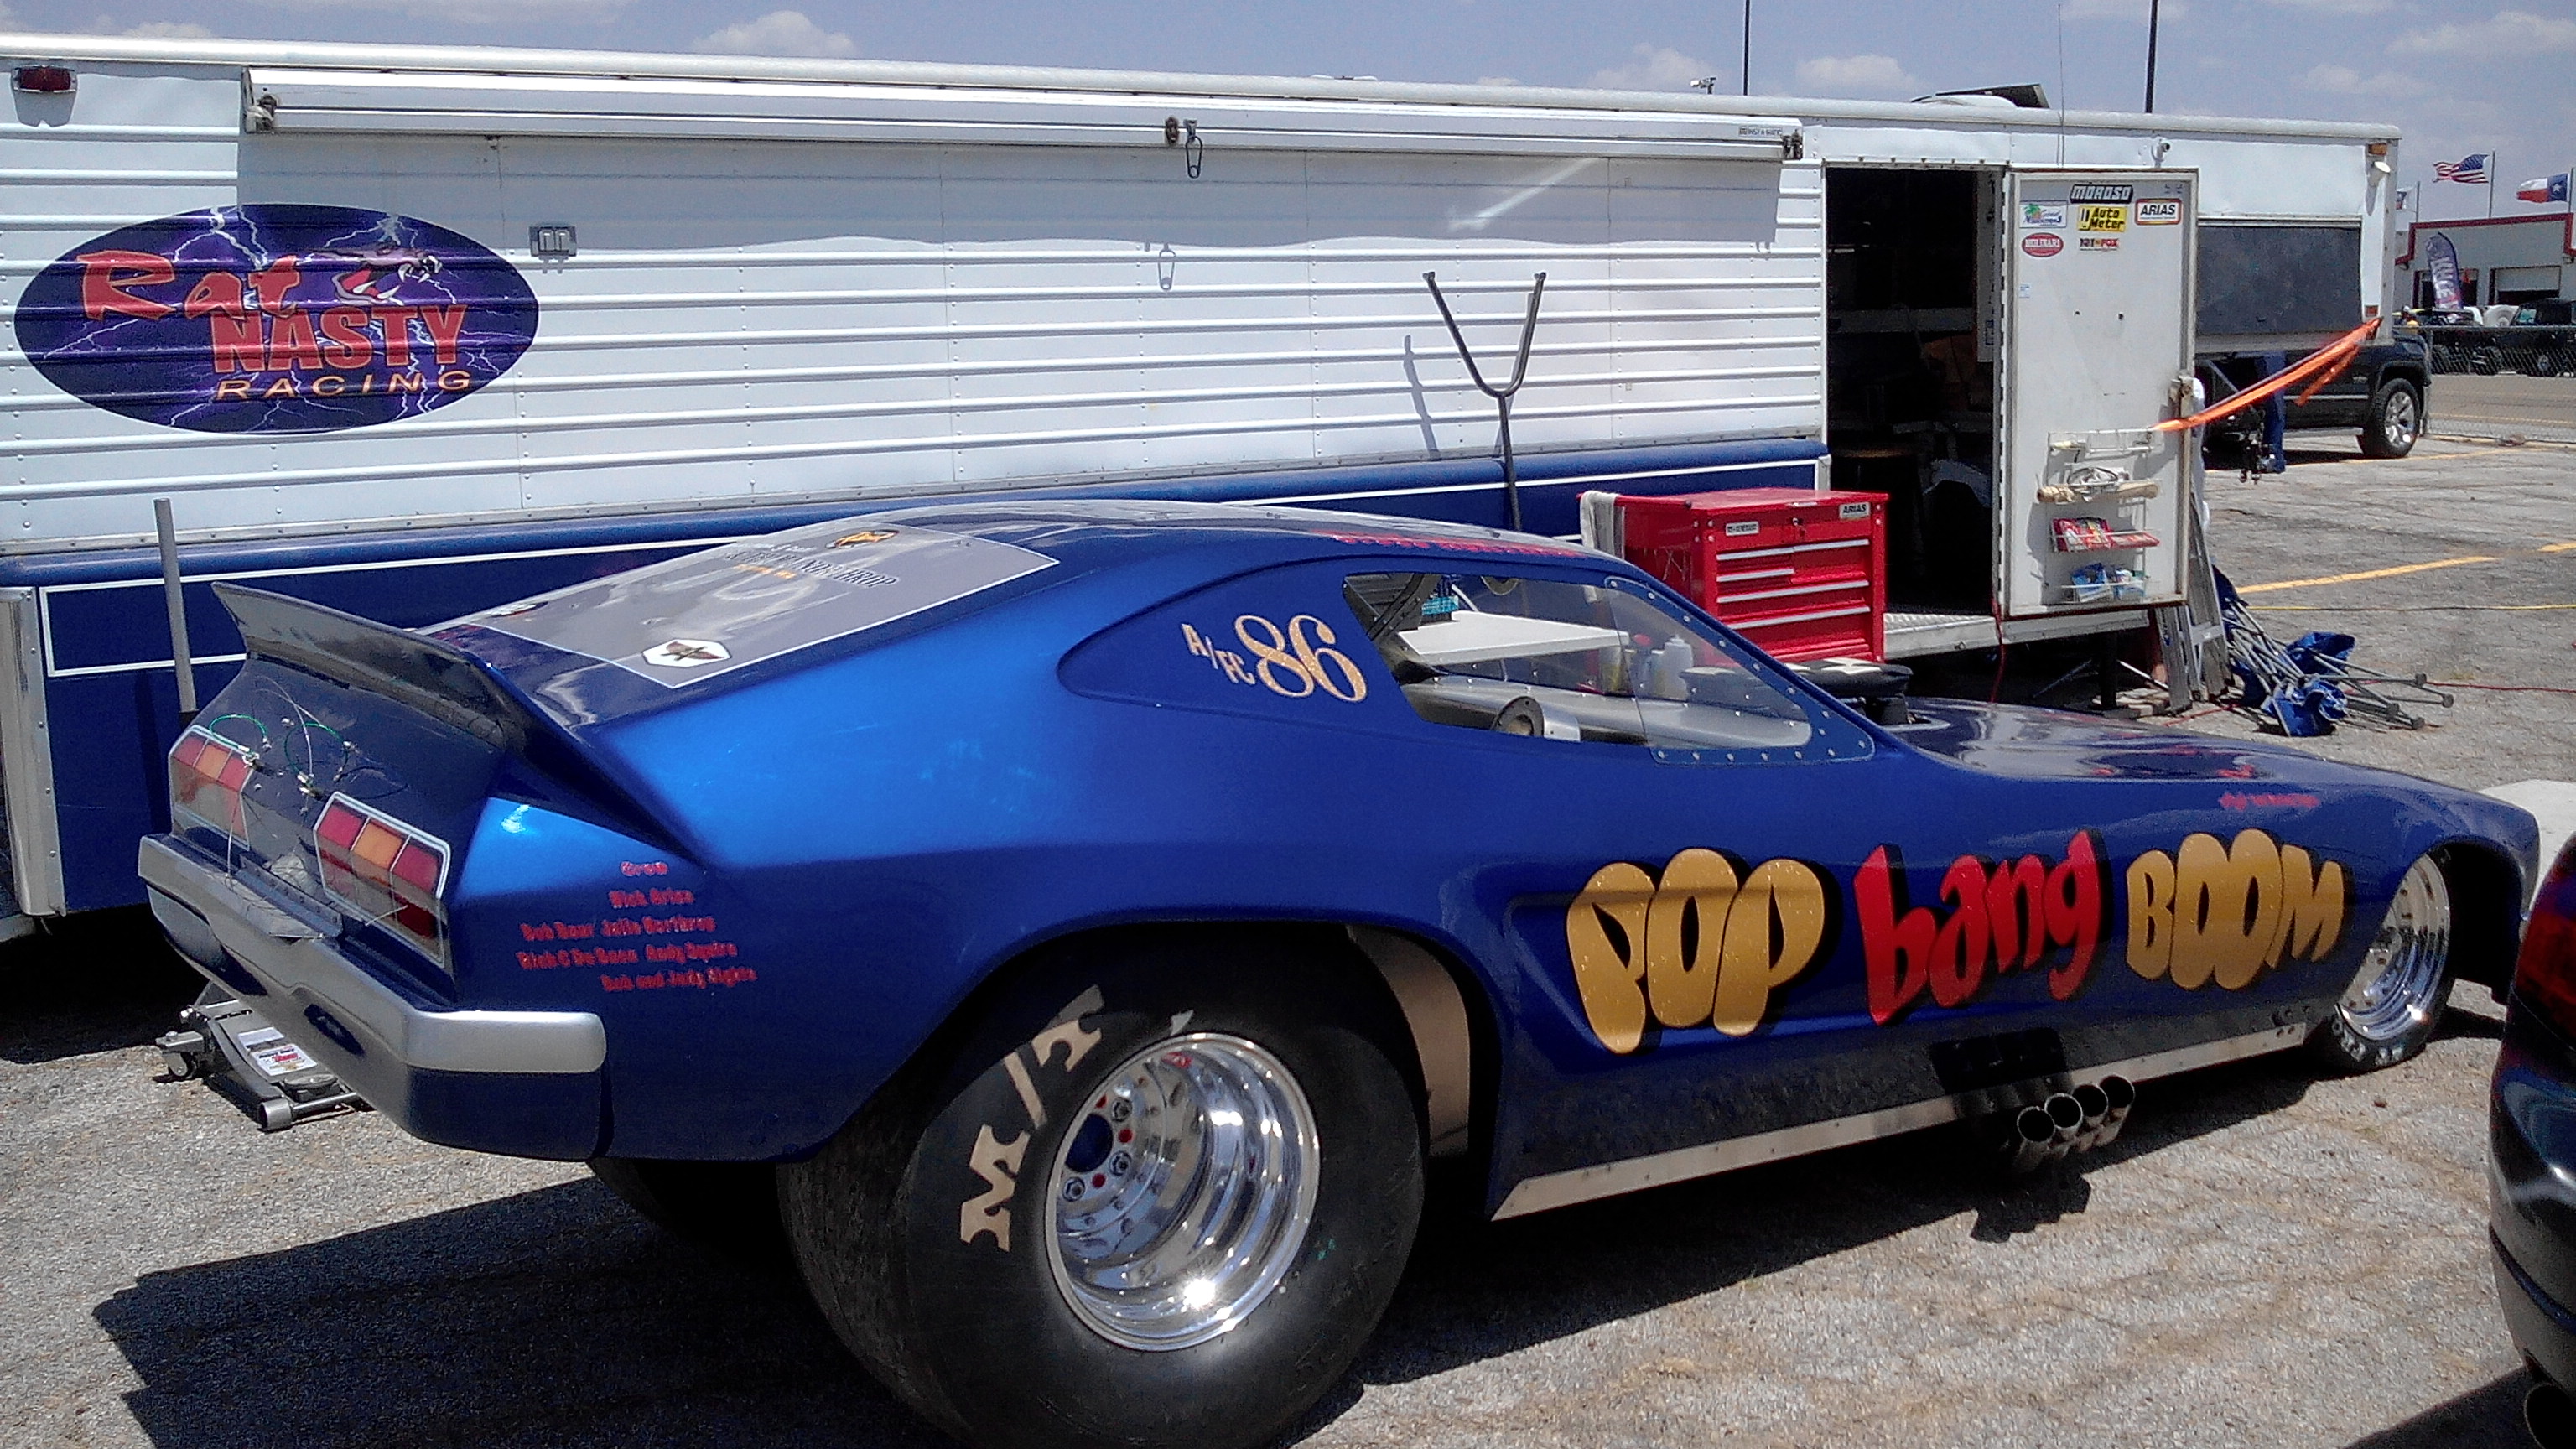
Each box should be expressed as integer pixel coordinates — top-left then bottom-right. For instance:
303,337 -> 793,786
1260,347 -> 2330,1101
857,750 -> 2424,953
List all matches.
1994,168 -> 2194,619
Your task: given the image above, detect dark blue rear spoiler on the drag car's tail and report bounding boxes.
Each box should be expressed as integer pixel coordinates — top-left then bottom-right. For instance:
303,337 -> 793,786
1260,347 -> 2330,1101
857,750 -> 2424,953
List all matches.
211,583 -> 688,854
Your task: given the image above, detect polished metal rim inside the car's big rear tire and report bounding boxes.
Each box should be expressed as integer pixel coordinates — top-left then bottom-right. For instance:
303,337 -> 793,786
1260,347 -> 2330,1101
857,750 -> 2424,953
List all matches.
1048,1031 -> 1319,1348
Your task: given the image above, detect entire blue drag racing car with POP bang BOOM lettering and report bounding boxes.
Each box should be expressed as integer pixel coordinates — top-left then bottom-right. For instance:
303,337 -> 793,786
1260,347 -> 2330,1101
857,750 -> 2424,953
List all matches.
139,503 -> 2535,1449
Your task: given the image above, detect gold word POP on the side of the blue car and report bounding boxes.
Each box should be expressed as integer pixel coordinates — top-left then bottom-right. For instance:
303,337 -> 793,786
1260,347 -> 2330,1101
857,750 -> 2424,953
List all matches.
1566,849 -> 1831,1055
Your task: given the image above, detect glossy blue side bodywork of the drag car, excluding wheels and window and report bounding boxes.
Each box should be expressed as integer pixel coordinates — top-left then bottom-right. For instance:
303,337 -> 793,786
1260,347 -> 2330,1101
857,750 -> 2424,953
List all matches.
146,503 -> 2532,1204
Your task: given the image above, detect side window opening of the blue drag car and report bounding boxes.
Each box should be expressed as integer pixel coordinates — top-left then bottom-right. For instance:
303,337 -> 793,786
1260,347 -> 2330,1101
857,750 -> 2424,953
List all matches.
1343,573 -> 1816,750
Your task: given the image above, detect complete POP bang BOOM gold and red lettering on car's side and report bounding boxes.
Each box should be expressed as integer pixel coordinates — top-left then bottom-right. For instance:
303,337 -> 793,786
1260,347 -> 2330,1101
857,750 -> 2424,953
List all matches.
1566,830 -> 2352,1055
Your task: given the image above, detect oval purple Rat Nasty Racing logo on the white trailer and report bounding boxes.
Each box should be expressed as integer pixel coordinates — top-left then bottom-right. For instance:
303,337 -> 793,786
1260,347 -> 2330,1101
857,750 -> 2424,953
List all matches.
18,206 -> 536,434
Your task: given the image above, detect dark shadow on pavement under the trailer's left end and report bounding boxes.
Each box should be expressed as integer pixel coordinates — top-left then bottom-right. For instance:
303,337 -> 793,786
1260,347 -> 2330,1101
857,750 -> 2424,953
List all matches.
0,907 -> 206,1067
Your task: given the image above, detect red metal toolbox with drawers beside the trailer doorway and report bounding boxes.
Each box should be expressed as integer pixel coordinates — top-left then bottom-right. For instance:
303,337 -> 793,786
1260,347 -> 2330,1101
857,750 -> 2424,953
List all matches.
1618,487 -> 1888,660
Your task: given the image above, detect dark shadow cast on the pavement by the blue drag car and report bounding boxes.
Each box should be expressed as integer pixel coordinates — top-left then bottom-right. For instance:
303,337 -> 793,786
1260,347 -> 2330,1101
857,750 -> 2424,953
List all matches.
96,1060 -> 2318,1449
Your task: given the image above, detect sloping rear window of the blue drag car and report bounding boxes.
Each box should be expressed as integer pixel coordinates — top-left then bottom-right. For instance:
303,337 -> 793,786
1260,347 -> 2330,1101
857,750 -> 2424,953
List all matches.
460,518 -> 1056,688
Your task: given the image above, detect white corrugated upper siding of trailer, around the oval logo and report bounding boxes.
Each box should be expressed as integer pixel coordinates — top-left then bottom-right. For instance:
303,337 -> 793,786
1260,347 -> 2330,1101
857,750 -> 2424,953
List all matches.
0,67 -> 1824,544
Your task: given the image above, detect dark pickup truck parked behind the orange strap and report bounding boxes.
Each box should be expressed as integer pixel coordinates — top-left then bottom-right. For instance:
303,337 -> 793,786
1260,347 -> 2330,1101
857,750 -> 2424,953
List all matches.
2194,333 -> 2434,472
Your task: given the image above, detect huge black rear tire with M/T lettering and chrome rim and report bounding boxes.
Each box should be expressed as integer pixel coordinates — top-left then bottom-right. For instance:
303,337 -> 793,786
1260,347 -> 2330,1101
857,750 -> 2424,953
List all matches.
781,933 -> 1425,1449
